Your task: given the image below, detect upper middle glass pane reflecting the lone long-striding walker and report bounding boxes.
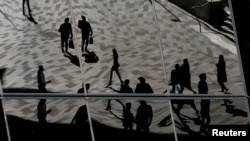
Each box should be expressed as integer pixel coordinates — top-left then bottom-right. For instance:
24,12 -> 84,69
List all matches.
72,0 -> 165,93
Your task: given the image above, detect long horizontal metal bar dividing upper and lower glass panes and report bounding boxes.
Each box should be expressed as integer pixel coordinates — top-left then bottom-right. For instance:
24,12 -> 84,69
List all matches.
0,93 -> 247,100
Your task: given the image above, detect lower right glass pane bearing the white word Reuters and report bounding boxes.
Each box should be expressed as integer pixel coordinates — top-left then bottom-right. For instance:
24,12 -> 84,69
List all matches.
172,99 -> 250,141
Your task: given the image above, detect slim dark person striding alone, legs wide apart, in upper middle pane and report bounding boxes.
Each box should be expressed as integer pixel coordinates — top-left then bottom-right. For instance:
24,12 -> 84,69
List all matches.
106,49 -> 123,88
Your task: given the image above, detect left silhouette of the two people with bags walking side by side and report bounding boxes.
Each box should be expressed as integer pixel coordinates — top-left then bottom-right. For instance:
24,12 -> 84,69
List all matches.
58,18 -> 73,53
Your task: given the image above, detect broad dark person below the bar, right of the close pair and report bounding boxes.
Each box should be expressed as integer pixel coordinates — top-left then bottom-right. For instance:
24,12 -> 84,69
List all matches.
135,100 -> 153,133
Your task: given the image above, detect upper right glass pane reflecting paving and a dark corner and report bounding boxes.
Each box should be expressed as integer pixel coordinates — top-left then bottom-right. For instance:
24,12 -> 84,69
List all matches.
152,0 -> 245,94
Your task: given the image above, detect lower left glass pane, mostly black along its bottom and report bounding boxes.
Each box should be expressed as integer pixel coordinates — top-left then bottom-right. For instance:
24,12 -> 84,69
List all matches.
4,99 -> 92,141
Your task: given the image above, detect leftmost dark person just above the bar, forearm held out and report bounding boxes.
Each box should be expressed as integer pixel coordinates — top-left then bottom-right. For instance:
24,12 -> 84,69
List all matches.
37,66 -> 51,93
